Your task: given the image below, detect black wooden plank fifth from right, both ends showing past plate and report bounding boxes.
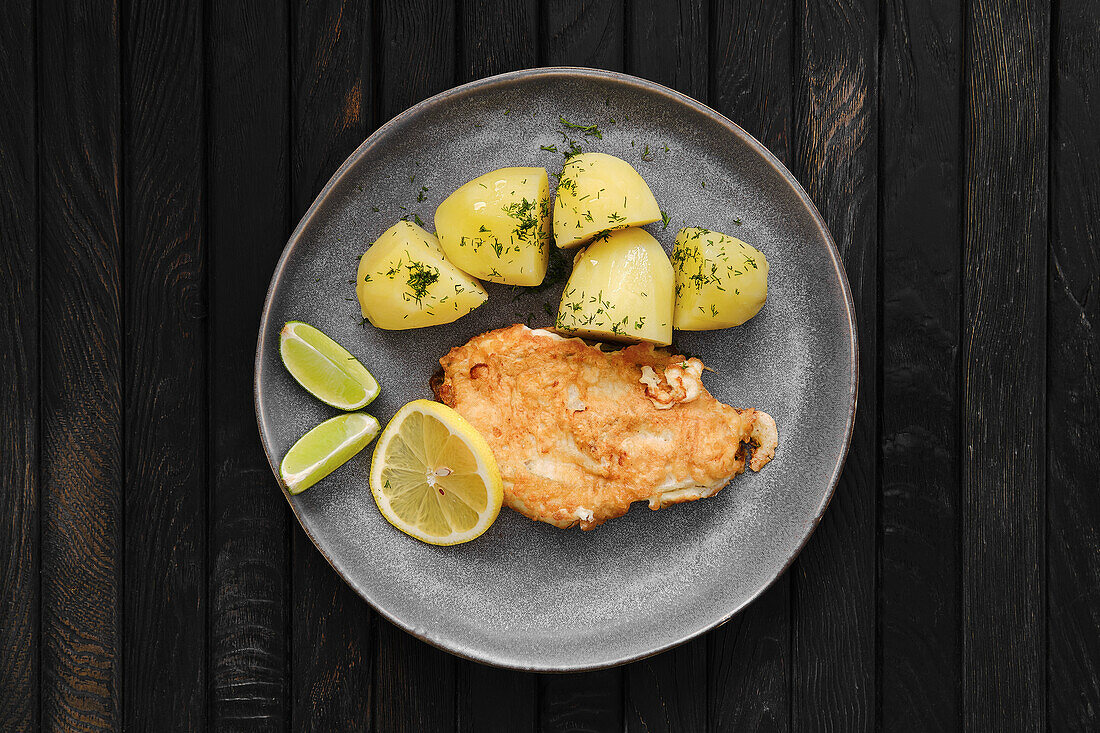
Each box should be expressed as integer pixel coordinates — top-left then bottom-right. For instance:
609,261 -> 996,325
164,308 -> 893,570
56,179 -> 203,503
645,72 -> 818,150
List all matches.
707,0 -> 794,731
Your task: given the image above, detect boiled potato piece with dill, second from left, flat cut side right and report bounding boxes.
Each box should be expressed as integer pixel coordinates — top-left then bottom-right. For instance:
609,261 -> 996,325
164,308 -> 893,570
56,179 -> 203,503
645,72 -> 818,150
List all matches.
436,168 -> 550,285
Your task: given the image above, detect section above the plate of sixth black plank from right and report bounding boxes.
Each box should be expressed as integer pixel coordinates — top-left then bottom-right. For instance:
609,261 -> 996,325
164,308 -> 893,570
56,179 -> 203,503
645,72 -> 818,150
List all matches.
625,0 -> 704,101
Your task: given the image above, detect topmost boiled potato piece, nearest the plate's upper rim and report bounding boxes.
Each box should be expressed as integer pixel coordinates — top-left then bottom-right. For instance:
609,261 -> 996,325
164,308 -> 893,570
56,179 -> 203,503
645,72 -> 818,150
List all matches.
553,153 -> 661,249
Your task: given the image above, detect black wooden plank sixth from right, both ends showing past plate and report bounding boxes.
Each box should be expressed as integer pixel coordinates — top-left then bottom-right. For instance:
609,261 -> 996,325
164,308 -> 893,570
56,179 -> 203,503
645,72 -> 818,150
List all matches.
623,5 -> 707,731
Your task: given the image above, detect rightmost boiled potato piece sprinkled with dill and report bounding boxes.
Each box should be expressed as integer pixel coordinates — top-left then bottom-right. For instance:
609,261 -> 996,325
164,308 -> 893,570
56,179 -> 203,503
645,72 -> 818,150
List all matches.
672,227 -> 768,331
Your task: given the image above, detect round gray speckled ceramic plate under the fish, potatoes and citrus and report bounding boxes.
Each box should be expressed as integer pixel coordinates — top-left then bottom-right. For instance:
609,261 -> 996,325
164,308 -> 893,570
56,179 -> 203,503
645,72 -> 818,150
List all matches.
255,68 -> 857,671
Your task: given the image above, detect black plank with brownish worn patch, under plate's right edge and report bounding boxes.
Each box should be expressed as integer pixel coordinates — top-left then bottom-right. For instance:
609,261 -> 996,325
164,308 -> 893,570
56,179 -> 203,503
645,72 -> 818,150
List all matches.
791,0 -> 879,731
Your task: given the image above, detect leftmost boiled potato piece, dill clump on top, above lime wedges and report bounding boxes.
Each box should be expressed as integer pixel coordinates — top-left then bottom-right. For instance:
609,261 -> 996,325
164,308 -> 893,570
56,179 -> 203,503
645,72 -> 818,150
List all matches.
355,221 -> 488,330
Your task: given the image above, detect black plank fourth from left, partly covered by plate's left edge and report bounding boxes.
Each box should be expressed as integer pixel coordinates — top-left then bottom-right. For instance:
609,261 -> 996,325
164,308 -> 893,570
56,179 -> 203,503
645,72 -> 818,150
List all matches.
206,0 -> 294,731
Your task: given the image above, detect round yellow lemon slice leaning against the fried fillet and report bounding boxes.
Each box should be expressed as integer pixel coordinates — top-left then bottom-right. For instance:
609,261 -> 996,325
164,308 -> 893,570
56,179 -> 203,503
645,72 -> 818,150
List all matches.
371,400 -> 504,545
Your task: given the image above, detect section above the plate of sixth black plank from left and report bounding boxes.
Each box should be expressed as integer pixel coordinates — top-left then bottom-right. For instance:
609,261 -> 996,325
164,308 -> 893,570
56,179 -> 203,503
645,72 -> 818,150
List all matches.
375,0 -> 457,122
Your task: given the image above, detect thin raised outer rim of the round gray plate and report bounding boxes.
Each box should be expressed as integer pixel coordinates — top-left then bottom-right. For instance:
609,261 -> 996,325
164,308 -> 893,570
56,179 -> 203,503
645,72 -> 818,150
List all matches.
252,66 -> 859,674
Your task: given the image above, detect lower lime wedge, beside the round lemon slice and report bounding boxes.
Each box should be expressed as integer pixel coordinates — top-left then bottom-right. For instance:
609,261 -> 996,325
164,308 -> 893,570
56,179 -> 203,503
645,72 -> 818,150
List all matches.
278,413 -> 378,494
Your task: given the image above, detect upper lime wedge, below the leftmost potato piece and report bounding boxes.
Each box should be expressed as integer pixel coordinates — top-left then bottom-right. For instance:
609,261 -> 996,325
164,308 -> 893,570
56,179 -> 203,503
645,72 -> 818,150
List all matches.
279,320 -> 378,412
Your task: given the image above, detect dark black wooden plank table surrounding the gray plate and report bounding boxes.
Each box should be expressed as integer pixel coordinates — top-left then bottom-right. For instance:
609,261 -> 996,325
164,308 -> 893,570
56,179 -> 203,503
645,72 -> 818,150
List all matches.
0,0 -> 1100,732
